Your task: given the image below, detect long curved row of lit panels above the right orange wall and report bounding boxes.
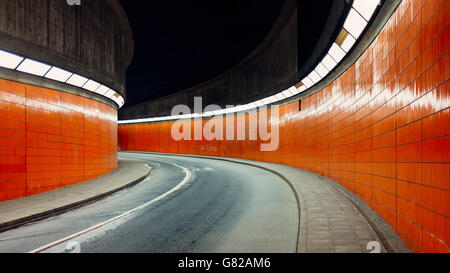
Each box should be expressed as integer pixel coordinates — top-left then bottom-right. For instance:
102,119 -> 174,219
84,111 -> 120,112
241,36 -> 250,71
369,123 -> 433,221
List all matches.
118,0 -> 380,124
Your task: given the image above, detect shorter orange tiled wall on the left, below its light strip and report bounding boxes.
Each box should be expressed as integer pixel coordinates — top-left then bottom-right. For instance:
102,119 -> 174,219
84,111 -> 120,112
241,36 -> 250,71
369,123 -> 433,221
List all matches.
0,79 -> 117,201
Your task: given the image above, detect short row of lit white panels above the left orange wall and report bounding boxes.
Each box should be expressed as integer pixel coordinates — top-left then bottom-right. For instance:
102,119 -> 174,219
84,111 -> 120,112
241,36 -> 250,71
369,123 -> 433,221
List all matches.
0,49 -> 125,108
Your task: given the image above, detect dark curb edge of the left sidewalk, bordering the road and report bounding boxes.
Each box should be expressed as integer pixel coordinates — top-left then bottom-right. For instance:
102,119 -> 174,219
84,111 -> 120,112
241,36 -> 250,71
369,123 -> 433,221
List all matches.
0,159 -> 151,233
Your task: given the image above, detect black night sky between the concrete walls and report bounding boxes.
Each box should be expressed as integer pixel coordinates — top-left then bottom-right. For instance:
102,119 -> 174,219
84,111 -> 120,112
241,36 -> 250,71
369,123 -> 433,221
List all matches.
120,0 -> 285,106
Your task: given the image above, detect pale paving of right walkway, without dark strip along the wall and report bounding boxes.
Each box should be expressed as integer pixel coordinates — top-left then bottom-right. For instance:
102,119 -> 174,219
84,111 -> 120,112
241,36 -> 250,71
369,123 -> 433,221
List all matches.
216,157 -> 387,253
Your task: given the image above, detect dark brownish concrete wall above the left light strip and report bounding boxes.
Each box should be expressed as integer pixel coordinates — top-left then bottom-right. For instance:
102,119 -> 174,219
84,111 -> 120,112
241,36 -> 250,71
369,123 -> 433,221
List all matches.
0,0 -> 133,97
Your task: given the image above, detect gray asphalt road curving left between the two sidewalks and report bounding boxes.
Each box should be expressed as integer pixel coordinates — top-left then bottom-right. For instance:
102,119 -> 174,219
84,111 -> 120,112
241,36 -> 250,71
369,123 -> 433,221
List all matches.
0,153 -> 299,253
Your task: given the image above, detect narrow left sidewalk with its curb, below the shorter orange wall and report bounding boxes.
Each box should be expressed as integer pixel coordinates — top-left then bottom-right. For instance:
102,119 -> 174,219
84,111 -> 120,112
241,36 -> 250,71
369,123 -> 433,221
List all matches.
0,160 -> 151,231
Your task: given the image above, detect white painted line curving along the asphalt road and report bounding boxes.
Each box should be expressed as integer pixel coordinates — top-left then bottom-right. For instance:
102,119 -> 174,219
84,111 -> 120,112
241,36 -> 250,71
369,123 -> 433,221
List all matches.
28,162 -> 192,253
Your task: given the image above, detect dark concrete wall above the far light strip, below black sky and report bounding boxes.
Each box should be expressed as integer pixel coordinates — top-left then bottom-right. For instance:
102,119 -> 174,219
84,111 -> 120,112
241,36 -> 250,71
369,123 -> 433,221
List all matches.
119,0 -> 298,119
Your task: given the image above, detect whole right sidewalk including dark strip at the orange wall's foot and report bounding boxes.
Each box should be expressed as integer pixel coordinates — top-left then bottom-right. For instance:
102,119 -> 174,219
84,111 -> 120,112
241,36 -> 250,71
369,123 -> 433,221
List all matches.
140,153 -> 411,253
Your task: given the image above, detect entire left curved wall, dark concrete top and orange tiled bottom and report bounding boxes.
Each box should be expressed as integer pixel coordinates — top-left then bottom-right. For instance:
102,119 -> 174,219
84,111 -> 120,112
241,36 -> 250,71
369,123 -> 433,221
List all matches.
0,0 -> 133,201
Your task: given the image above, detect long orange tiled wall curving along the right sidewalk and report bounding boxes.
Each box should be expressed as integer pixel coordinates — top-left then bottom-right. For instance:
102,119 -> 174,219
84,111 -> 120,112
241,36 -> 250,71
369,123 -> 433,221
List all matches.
119,0 -> 450,252
